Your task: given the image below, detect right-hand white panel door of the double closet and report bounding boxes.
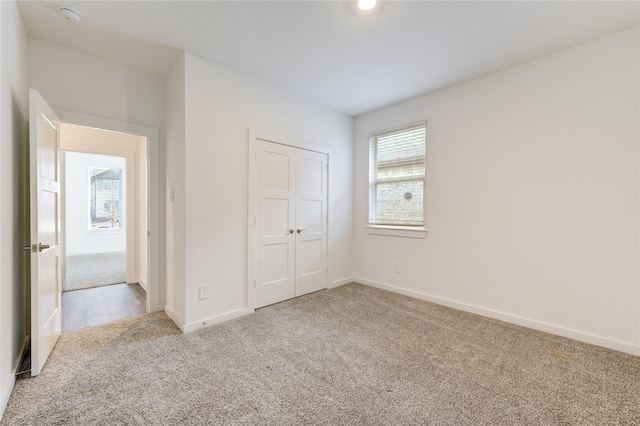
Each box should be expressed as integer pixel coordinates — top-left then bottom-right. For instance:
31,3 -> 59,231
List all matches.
296,149 -> 327,296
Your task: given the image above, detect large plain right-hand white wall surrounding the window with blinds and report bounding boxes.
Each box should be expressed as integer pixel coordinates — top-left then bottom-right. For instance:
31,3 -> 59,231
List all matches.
354,27 -> 640,354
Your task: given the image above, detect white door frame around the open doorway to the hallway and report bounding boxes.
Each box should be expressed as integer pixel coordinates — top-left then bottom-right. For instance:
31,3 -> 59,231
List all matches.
56,110 -> 164,312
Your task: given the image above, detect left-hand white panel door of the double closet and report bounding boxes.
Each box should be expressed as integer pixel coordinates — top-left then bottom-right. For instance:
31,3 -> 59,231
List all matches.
255,142 -> 296,308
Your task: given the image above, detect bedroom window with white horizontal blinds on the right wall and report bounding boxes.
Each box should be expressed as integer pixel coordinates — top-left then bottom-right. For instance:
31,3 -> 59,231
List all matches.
369,124 -> 426,228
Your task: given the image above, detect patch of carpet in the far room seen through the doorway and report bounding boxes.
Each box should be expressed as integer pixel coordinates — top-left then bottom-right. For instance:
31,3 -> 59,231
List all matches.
65,252 -> 127,291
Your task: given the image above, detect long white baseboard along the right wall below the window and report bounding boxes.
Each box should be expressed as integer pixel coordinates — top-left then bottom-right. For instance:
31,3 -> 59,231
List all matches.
353,277 -> 640,356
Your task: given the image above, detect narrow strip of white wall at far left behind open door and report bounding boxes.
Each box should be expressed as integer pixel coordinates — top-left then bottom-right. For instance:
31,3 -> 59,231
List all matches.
0,1 -> 29,415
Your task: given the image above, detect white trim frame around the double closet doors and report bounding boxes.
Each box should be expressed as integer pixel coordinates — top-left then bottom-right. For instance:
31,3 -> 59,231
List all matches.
246,128 -> 333,310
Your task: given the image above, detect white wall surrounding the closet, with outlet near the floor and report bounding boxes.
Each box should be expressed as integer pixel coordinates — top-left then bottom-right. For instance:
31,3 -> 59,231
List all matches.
165,53 -> 353,329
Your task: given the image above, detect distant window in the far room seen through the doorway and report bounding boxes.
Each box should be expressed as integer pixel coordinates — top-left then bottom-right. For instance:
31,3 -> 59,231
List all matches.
89,167 -> 122,229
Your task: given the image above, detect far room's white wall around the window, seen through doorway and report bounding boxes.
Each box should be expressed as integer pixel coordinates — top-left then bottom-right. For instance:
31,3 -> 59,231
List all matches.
65,152 -> 126,256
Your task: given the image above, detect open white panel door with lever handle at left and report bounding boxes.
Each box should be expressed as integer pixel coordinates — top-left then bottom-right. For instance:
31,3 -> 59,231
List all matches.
29,89 -> 62,376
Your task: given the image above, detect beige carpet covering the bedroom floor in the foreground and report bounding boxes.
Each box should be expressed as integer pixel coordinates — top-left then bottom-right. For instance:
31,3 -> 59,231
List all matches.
2,284 -> 640,425
